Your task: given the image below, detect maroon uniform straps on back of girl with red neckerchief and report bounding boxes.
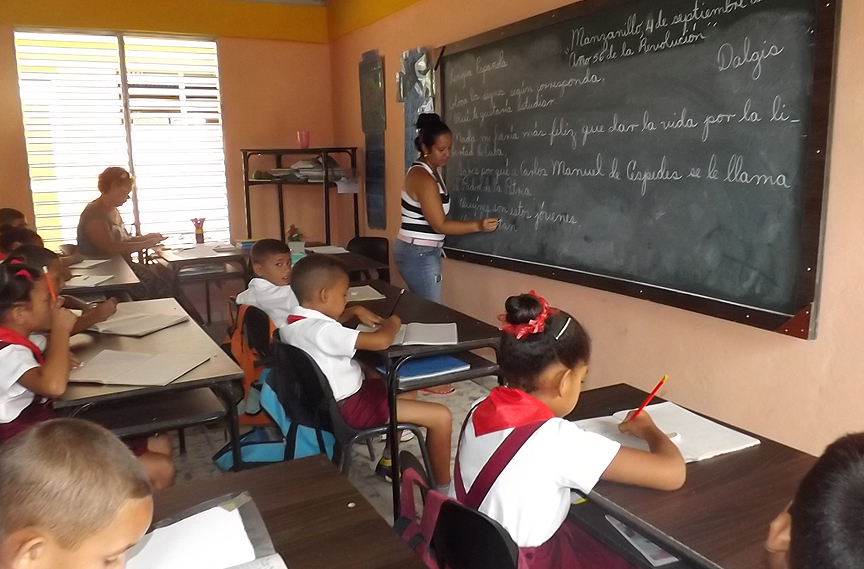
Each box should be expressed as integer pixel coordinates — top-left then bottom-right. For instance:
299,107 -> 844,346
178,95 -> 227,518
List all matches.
453,409 -> 546,510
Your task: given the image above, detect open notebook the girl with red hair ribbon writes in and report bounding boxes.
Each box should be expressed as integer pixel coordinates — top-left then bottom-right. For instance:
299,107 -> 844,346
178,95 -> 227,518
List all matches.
575,401 -> 759,462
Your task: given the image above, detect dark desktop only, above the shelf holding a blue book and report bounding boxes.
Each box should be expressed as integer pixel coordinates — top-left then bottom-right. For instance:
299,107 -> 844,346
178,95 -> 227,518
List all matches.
352,278 -> 501,359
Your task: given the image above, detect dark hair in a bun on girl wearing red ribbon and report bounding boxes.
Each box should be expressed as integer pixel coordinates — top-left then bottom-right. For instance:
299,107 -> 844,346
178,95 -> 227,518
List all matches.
499,294 -> 591,393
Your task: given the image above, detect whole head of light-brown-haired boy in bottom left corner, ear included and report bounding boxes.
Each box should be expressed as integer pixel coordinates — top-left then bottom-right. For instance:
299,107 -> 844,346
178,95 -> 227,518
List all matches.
0,419 -> 153,569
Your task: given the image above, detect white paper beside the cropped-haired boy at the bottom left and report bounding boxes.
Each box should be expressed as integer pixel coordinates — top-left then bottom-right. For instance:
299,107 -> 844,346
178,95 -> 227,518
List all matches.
126,507 -> 256,569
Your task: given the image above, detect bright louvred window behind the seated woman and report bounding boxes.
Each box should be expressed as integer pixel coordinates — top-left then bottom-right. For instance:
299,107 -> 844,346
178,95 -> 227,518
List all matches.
15,32 -> 229,245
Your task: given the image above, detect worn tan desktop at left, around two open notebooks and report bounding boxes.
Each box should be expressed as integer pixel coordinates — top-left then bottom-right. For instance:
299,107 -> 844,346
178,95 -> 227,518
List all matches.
54,298 -> 243,407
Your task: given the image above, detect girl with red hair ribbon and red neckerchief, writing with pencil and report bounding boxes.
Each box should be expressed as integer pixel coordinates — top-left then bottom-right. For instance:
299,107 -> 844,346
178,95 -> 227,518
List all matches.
451,292 -> 686,569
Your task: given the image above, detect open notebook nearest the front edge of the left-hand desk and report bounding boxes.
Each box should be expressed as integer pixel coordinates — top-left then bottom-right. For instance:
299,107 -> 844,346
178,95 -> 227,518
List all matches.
69,350 -> 210,387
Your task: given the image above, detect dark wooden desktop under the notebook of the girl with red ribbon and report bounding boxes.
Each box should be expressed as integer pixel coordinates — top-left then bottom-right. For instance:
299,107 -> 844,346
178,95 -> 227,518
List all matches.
567,384 -> 816,569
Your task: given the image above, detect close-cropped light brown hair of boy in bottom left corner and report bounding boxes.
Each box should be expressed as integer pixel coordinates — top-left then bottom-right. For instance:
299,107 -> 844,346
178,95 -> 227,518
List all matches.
0,419 -> 152,549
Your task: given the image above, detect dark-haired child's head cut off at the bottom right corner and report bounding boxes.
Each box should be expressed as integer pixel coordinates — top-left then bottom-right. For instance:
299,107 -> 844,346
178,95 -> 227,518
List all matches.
765,433 -> 864,569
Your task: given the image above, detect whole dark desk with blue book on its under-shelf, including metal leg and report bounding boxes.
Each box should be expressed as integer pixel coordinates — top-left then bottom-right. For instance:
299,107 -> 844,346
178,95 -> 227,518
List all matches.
352,280 -> 501,517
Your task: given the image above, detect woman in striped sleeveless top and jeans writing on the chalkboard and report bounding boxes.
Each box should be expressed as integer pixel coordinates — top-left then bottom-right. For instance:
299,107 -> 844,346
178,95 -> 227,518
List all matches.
393,113 -> 498,302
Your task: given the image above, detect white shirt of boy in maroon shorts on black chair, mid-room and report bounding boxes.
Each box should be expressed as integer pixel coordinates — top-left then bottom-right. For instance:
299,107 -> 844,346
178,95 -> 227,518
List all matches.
279,306 -> 363,401
